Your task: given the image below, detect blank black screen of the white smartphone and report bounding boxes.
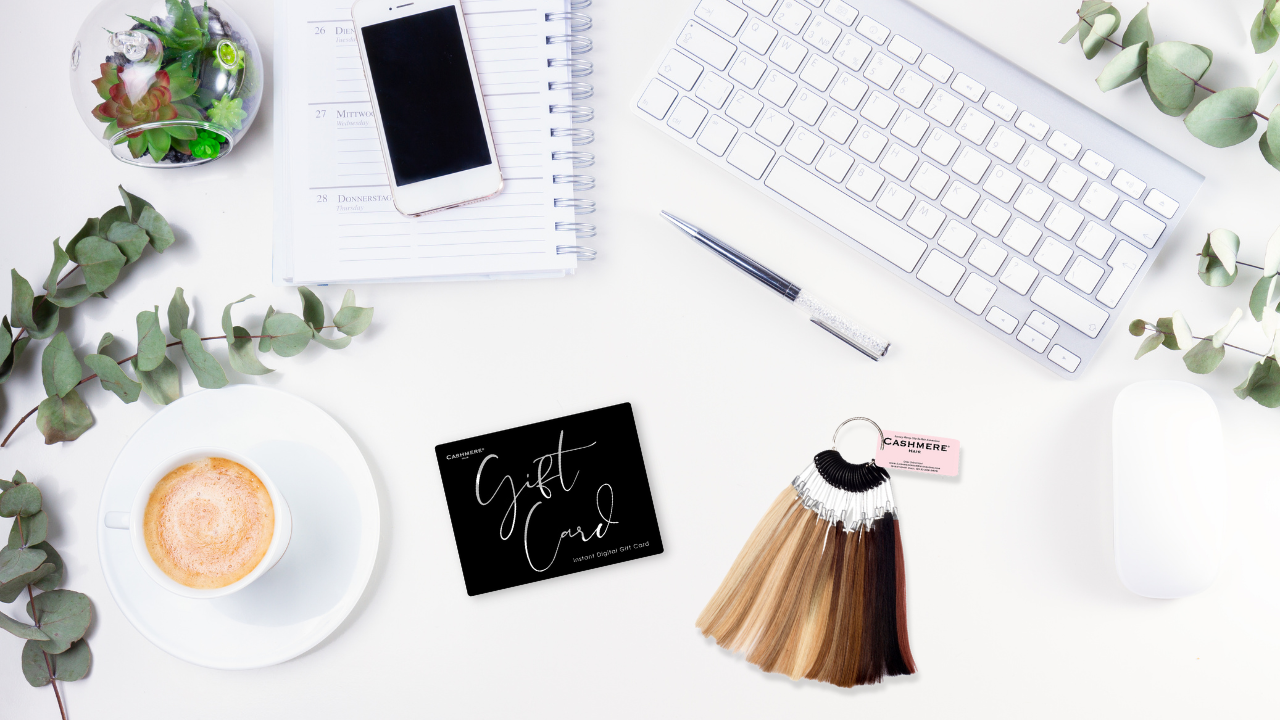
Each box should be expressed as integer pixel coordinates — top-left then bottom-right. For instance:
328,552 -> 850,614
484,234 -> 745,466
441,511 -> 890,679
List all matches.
364,6 -> 493,186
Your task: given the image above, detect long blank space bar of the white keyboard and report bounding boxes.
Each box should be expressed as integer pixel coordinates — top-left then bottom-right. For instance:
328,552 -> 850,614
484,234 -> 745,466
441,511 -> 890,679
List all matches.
764,158 -> 928,273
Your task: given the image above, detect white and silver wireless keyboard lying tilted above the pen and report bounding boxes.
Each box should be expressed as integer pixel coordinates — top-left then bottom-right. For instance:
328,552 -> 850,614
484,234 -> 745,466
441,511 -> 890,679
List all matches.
632,0 -> 1204,378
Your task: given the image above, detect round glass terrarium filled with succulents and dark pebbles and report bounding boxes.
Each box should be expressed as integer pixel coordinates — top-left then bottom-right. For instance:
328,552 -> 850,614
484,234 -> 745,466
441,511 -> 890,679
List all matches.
70,0 -> 262,168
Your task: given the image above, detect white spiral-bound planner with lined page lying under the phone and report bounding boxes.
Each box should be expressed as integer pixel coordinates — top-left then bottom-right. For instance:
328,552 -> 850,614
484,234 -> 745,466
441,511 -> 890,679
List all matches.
271,0 -> 595,284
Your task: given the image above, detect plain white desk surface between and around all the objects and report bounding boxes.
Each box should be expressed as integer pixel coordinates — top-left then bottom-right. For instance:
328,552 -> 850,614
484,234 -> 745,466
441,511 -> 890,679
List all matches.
0,0 -> 1280,720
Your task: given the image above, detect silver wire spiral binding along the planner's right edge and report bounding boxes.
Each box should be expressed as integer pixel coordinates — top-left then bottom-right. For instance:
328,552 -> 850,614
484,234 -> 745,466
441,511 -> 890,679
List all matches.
544,0 -> 596,252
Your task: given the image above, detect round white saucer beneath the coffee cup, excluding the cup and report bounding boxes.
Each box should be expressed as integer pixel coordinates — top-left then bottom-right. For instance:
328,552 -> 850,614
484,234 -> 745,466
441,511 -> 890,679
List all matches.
97,384 -> 379,670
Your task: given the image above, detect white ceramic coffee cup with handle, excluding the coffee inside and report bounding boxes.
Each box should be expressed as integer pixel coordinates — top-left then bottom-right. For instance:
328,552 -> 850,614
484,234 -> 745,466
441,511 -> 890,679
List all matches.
104,447 -> 293,600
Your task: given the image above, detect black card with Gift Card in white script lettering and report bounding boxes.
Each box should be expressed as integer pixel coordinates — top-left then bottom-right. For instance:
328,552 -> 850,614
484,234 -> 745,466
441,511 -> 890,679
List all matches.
435,404 -> 662,596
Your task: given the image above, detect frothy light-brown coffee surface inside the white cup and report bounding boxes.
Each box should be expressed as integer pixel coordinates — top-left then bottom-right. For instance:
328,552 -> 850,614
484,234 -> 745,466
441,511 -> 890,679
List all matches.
142,457 -> 275,589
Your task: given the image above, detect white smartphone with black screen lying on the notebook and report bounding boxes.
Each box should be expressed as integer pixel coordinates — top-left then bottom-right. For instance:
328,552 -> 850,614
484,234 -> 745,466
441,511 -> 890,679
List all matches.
351,0 -> 502,215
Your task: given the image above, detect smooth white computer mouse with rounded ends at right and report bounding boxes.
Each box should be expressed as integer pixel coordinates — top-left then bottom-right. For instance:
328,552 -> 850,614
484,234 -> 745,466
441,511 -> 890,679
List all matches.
1111,380 -> 1226,598
